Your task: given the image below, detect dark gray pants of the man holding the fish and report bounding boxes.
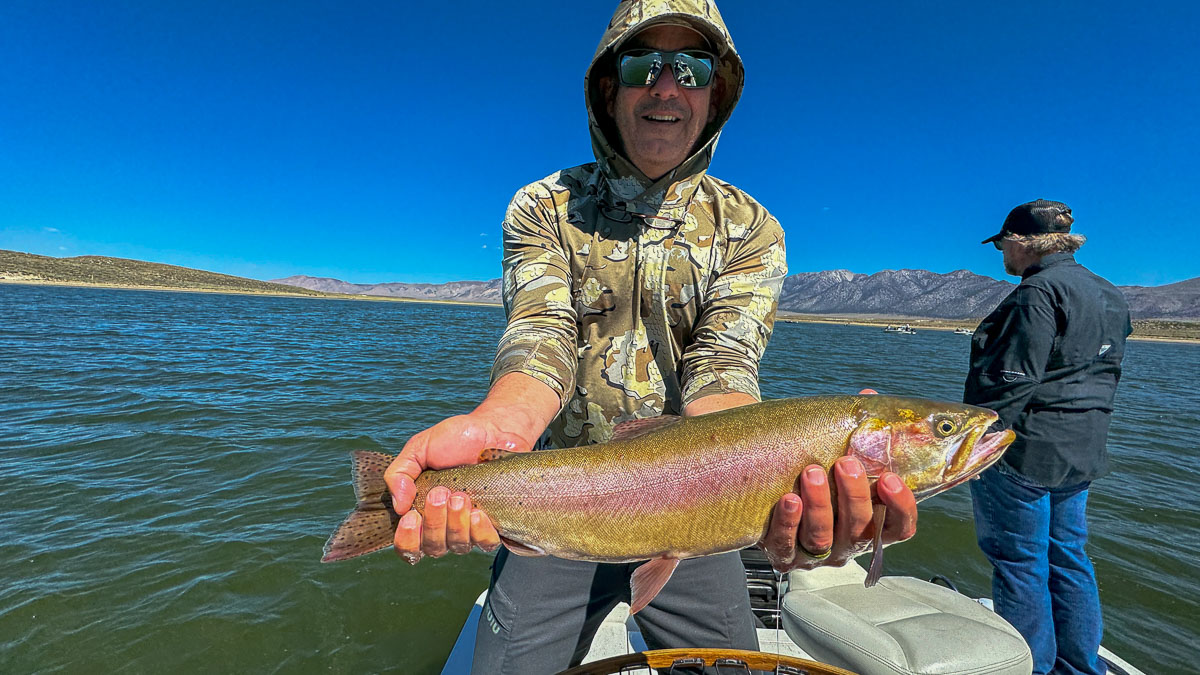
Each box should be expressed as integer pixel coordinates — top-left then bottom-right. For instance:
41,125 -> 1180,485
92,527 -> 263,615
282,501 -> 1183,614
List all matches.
472,549 -> 758,675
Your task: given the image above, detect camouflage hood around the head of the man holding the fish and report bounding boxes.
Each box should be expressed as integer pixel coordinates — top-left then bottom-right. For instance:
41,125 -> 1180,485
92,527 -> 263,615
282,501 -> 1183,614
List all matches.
583,0 -> 745,220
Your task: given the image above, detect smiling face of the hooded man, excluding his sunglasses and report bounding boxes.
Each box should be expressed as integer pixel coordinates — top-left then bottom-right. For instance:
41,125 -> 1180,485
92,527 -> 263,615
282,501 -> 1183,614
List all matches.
608,25 -> 716,179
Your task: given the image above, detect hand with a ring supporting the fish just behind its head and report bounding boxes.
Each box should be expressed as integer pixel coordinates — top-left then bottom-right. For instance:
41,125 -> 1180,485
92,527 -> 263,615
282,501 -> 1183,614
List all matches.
760,389 -> 917,572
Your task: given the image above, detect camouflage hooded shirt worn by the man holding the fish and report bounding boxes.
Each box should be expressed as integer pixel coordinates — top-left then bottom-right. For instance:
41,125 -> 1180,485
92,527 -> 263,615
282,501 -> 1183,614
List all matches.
492,0 -> 787,447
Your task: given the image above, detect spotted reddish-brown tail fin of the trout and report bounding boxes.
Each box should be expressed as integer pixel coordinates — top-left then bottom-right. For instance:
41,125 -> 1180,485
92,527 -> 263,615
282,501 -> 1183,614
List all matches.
320,450 -> 400,562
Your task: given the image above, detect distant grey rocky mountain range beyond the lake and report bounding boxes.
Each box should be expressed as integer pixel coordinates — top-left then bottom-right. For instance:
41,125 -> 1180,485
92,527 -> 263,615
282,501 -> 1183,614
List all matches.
272,269 -> 1200,319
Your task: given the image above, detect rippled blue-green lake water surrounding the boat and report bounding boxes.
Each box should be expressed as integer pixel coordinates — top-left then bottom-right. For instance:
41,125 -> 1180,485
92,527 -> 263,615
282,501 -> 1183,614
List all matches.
0,285 -> 1200,674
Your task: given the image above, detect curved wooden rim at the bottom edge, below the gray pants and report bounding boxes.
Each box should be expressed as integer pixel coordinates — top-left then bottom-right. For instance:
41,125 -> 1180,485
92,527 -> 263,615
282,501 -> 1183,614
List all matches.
558,649 -> 856,675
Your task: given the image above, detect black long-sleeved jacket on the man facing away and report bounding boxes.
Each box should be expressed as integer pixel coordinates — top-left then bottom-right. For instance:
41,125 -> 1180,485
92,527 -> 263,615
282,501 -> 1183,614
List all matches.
962,253 -> 1133,488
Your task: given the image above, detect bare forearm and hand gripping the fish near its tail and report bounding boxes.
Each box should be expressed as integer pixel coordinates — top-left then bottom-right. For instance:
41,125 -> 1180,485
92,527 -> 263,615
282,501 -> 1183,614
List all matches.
384,374 -> 558,565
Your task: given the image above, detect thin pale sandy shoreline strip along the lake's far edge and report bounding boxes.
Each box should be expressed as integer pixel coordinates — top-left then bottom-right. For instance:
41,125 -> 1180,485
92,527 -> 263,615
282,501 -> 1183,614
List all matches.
9,276 -> 1200,345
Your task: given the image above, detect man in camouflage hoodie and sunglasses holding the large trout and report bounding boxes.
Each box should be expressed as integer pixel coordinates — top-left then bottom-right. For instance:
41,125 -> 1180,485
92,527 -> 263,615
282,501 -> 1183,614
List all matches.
385,0 -> 917,673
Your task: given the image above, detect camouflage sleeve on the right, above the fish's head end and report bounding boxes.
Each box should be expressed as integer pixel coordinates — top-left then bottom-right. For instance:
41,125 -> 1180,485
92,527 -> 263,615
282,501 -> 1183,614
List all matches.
683,210 -> 787,406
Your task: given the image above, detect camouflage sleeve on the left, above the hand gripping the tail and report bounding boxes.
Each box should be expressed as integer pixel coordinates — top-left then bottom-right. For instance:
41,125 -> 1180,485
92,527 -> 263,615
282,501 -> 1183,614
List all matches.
492,183 -> 578,406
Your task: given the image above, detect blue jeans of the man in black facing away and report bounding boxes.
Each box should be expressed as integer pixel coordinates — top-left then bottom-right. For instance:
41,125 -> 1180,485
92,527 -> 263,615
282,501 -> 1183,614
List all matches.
971,465 -> 1108,675
